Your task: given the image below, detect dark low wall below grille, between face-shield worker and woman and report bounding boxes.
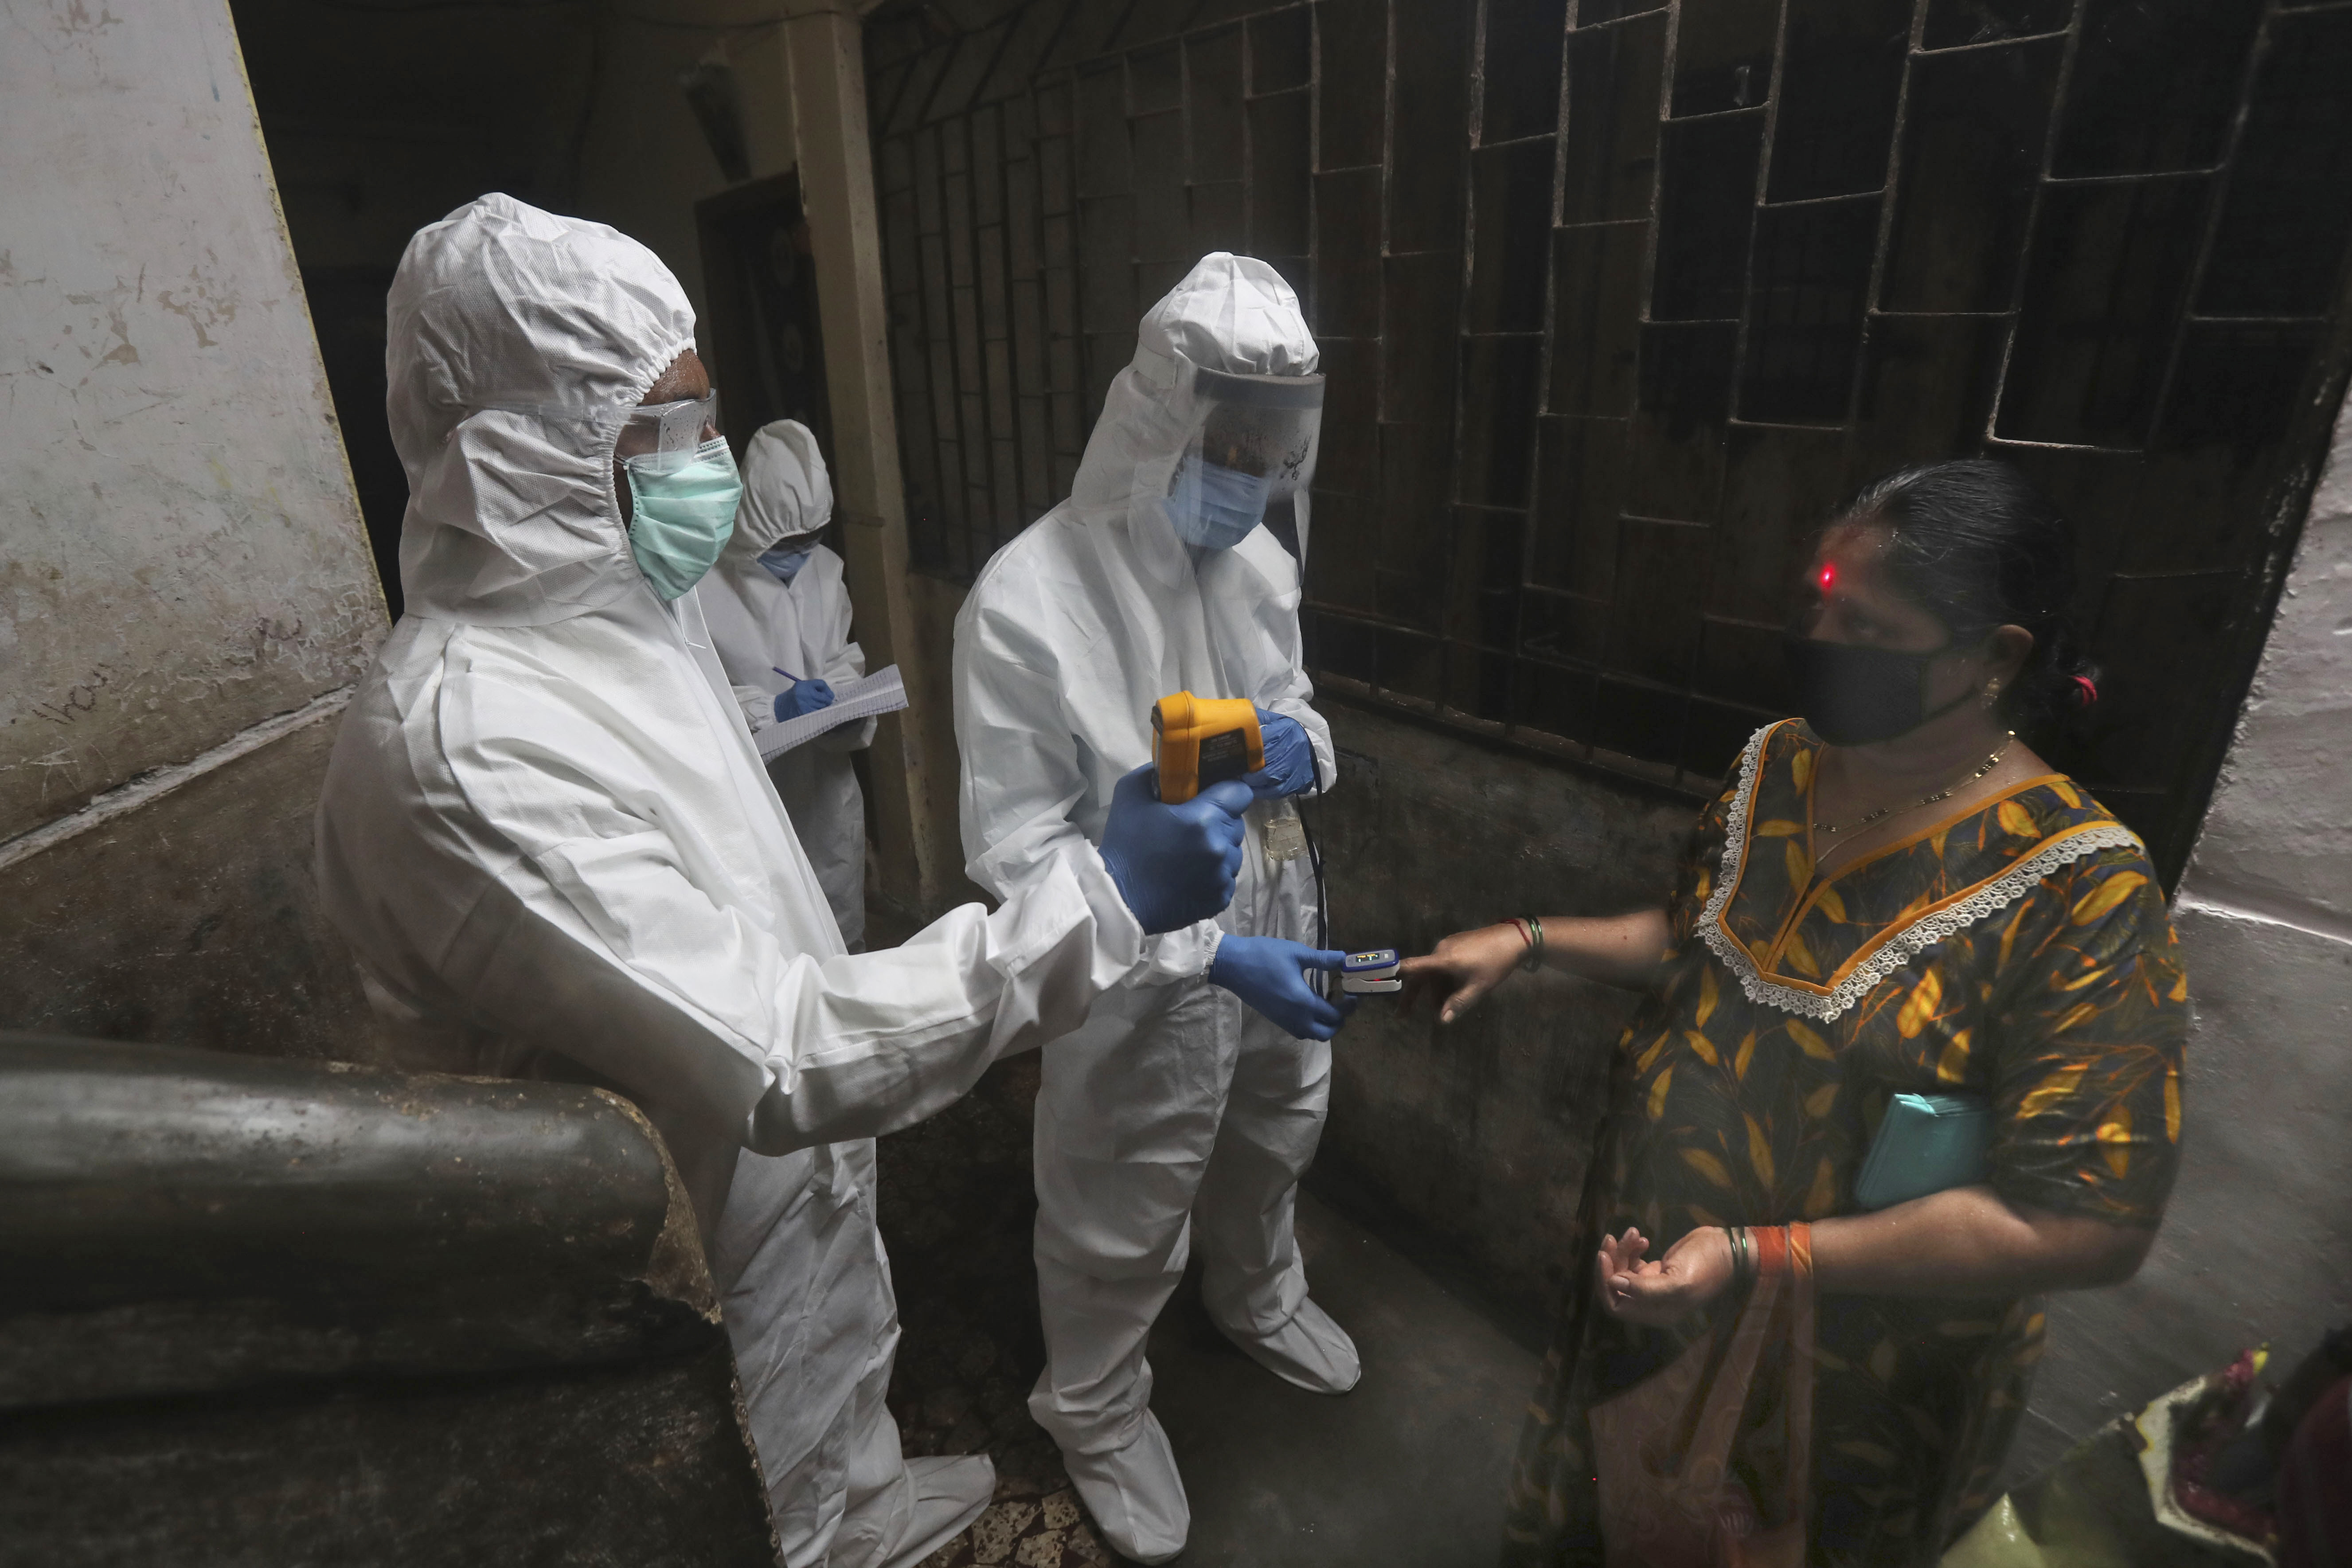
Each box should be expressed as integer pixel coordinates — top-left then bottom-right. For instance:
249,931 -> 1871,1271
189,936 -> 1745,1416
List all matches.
1308,700 -> 1698,1335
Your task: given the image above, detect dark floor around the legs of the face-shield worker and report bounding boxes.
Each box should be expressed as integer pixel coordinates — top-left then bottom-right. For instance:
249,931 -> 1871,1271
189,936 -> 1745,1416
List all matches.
882,1058 -> 1536,1568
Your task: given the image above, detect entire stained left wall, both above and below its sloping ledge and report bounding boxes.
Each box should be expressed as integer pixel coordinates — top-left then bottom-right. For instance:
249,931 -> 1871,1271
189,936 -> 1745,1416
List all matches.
0,0 -> 383,1053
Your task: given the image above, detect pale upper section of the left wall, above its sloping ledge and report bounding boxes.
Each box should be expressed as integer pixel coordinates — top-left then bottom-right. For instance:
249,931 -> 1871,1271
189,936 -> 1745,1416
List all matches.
0,0 -> 383,839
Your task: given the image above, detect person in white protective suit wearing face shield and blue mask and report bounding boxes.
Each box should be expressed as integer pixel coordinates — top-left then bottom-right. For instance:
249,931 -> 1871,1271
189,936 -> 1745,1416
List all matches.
955,251 -> 1360,1563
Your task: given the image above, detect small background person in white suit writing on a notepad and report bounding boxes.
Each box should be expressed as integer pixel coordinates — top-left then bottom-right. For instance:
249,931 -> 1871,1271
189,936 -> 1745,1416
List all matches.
694,418 -> 875,952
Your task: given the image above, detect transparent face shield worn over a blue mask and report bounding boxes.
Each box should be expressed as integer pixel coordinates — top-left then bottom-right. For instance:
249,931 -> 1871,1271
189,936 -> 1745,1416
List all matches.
1169,367 -> 1324,550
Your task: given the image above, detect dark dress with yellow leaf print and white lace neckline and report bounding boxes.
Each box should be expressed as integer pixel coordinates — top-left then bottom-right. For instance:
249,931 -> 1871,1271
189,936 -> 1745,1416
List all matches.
1503,719 -> 2188,1568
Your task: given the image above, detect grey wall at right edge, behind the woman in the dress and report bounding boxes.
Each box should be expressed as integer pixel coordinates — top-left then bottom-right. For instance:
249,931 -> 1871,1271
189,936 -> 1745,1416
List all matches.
2020,385 -> 2352,1462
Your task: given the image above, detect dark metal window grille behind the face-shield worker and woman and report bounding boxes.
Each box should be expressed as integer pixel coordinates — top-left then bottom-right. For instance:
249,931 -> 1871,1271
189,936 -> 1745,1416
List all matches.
868,0 -> 2352,875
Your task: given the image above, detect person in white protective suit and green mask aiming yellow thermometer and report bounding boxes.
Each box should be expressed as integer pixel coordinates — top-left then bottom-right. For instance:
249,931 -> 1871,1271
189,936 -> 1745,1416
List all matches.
317,195 -> 1249,1568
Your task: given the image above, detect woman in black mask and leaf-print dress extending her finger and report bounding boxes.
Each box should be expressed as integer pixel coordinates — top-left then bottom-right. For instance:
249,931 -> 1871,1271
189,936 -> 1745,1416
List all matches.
1407,461 -> 2188,1568
